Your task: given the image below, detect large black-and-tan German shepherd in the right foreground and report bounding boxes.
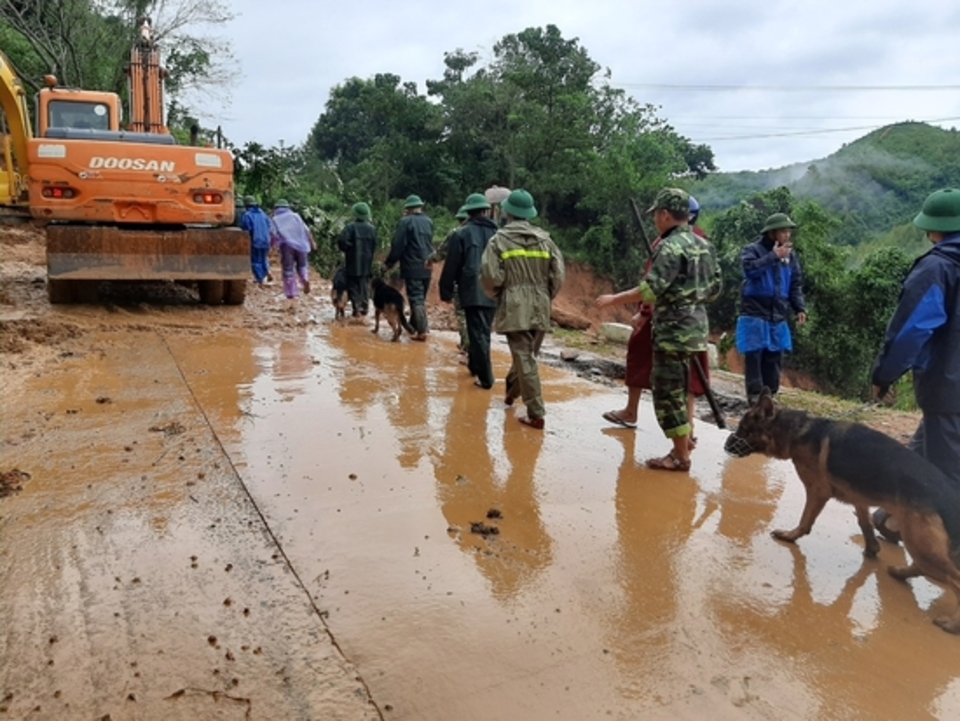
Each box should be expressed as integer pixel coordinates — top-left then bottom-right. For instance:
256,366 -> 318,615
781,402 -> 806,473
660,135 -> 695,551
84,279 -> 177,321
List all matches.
725,388 -> 960,634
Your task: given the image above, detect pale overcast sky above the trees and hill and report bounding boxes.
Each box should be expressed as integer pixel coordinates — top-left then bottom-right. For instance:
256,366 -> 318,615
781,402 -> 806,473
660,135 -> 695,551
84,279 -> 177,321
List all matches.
201,0 -> 960,171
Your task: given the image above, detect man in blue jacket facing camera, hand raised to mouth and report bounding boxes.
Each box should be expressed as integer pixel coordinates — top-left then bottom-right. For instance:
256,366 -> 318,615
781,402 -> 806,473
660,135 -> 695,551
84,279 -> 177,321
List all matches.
737,213 -> 807,405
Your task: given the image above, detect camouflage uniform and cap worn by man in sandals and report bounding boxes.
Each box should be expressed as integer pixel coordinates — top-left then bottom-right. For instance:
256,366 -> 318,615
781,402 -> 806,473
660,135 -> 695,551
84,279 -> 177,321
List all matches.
638,190 -> 721,438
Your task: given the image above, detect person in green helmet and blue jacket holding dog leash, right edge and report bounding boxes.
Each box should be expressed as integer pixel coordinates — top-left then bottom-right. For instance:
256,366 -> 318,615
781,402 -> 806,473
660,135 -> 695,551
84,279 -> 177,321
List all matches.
871,188 -> 960,541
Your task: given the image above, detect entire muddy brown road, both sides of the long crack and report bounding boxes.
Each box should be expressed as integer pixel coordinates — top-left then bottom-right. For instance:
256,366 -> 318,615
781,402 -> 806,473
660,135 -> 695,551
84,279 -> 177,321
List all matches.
0,226 -> 960,721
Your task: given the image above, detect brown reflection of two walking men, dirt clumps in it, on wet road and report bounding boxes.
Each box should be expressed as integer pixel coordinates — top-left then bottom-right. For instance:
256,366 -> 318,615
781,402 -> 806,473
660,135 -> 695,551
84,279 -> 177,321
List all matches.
433,384 -> 552,600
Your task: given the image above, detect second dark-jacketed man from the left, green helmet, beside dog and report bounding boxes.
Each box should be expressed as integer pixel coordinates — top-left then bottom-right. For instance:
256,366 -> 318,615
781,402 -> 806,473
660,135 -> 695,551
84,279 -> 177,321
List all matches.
385,195 -> 433,341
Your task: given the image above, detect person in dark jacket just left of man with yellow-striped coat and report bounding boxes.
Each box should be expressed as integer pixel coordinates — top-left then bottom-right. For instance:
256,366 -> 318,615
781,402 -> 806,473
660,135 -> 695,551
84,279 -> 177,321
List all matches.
440,193 -> 497,389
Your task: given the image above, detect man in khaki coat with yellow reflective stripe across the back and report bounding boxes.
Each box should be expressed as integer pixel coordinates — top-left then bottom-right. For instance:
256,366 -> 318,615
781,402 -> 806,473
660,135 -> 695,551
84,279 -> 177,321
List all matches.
480,190 -> 564,429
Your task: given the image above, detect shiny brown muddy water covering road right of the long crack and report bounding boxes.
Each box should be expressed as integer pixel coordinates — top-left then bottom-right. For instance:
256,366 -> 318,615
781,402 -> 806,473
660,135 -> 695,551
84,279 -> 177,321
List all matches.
161,325 -> 960,719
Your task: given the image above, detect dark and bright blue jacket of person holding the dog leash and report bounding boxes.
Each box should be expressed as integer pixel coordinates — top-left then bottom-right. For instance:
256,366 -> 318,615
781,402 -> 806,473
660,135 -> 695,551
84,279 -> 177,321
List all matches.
872,233 -> 960,413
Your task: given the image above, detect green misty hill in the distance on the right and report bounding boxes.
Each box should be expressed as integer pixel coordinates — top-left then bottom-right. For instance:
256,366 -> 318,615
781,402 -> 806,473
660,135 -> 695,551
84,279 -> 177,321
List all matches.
691,122 -> 960,245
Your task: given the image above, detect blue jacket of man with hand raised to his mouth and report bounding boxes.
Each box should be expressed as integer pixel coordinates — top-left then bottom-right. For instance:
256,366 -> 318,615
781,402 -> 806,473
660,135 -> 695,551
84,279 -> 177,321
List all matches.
740,236 -> 807,323
